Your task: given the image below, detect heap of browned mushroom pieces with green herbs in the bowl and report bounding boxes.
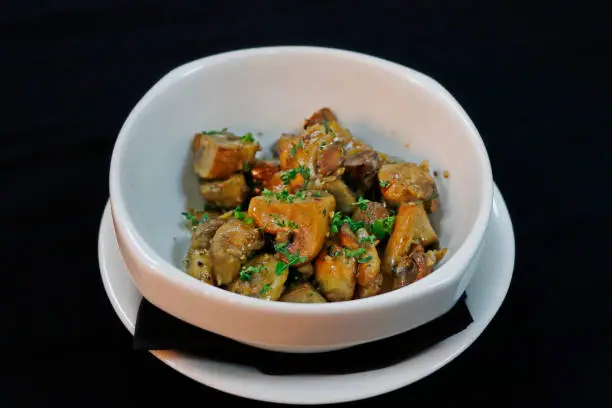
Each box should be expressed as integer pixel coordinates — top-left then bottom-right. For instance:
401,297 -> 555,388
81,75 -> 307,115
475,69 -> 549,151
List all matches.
183,108 -> 447,303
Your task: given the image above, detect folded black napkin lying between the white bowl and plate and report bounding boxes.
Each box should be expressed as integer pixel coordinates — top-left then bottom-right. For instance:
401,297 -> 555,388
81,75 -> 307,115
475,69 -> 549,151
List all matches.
133,293 -> 473,375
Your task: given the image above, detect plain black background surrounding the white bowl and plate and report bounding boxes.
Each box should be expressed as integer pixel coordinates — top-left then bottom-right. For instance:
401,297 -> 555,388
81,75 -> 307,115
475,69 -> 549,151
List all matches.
0,0 -> 612,407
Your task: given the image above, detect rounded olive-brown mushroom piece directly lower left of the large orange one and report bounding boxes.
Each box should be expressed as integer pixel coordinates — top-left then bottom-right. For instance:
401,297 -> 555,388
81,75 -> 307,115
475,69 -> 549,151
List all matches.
211,218 -> 264,286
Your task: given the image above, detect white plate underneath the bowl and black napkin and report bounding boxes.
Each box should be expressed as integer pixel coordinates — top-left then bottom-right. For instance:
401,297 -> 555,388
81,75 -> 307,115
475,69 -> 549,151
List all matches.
98,187 -> 514,404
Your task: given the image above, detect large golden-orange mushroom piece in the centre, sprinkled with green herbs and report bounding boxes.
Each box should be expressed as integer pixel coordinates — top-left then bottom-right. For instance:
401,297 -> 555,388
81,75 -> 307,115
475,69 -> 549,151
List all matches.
248,192 -> 336,267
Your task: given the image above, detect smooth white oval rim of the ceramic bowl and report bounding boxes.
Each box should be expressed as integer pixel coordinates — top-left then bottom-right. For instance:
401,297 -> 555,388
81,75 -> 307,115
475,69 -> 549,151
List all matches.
109,45 -> 493,316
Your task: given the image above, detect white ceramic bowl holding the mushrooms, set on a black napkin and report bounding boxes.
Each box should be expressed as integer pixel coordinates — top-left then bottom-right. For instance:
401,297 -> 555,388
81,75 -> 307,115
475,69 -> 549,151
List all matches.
110,47 -> 493,352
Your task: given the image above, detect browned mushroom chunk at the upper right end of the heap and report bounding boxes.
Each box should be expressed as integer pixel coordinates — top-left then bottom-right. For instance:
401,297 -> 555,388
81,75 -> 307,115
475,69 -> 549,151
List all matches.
378,161 -> 437,207
